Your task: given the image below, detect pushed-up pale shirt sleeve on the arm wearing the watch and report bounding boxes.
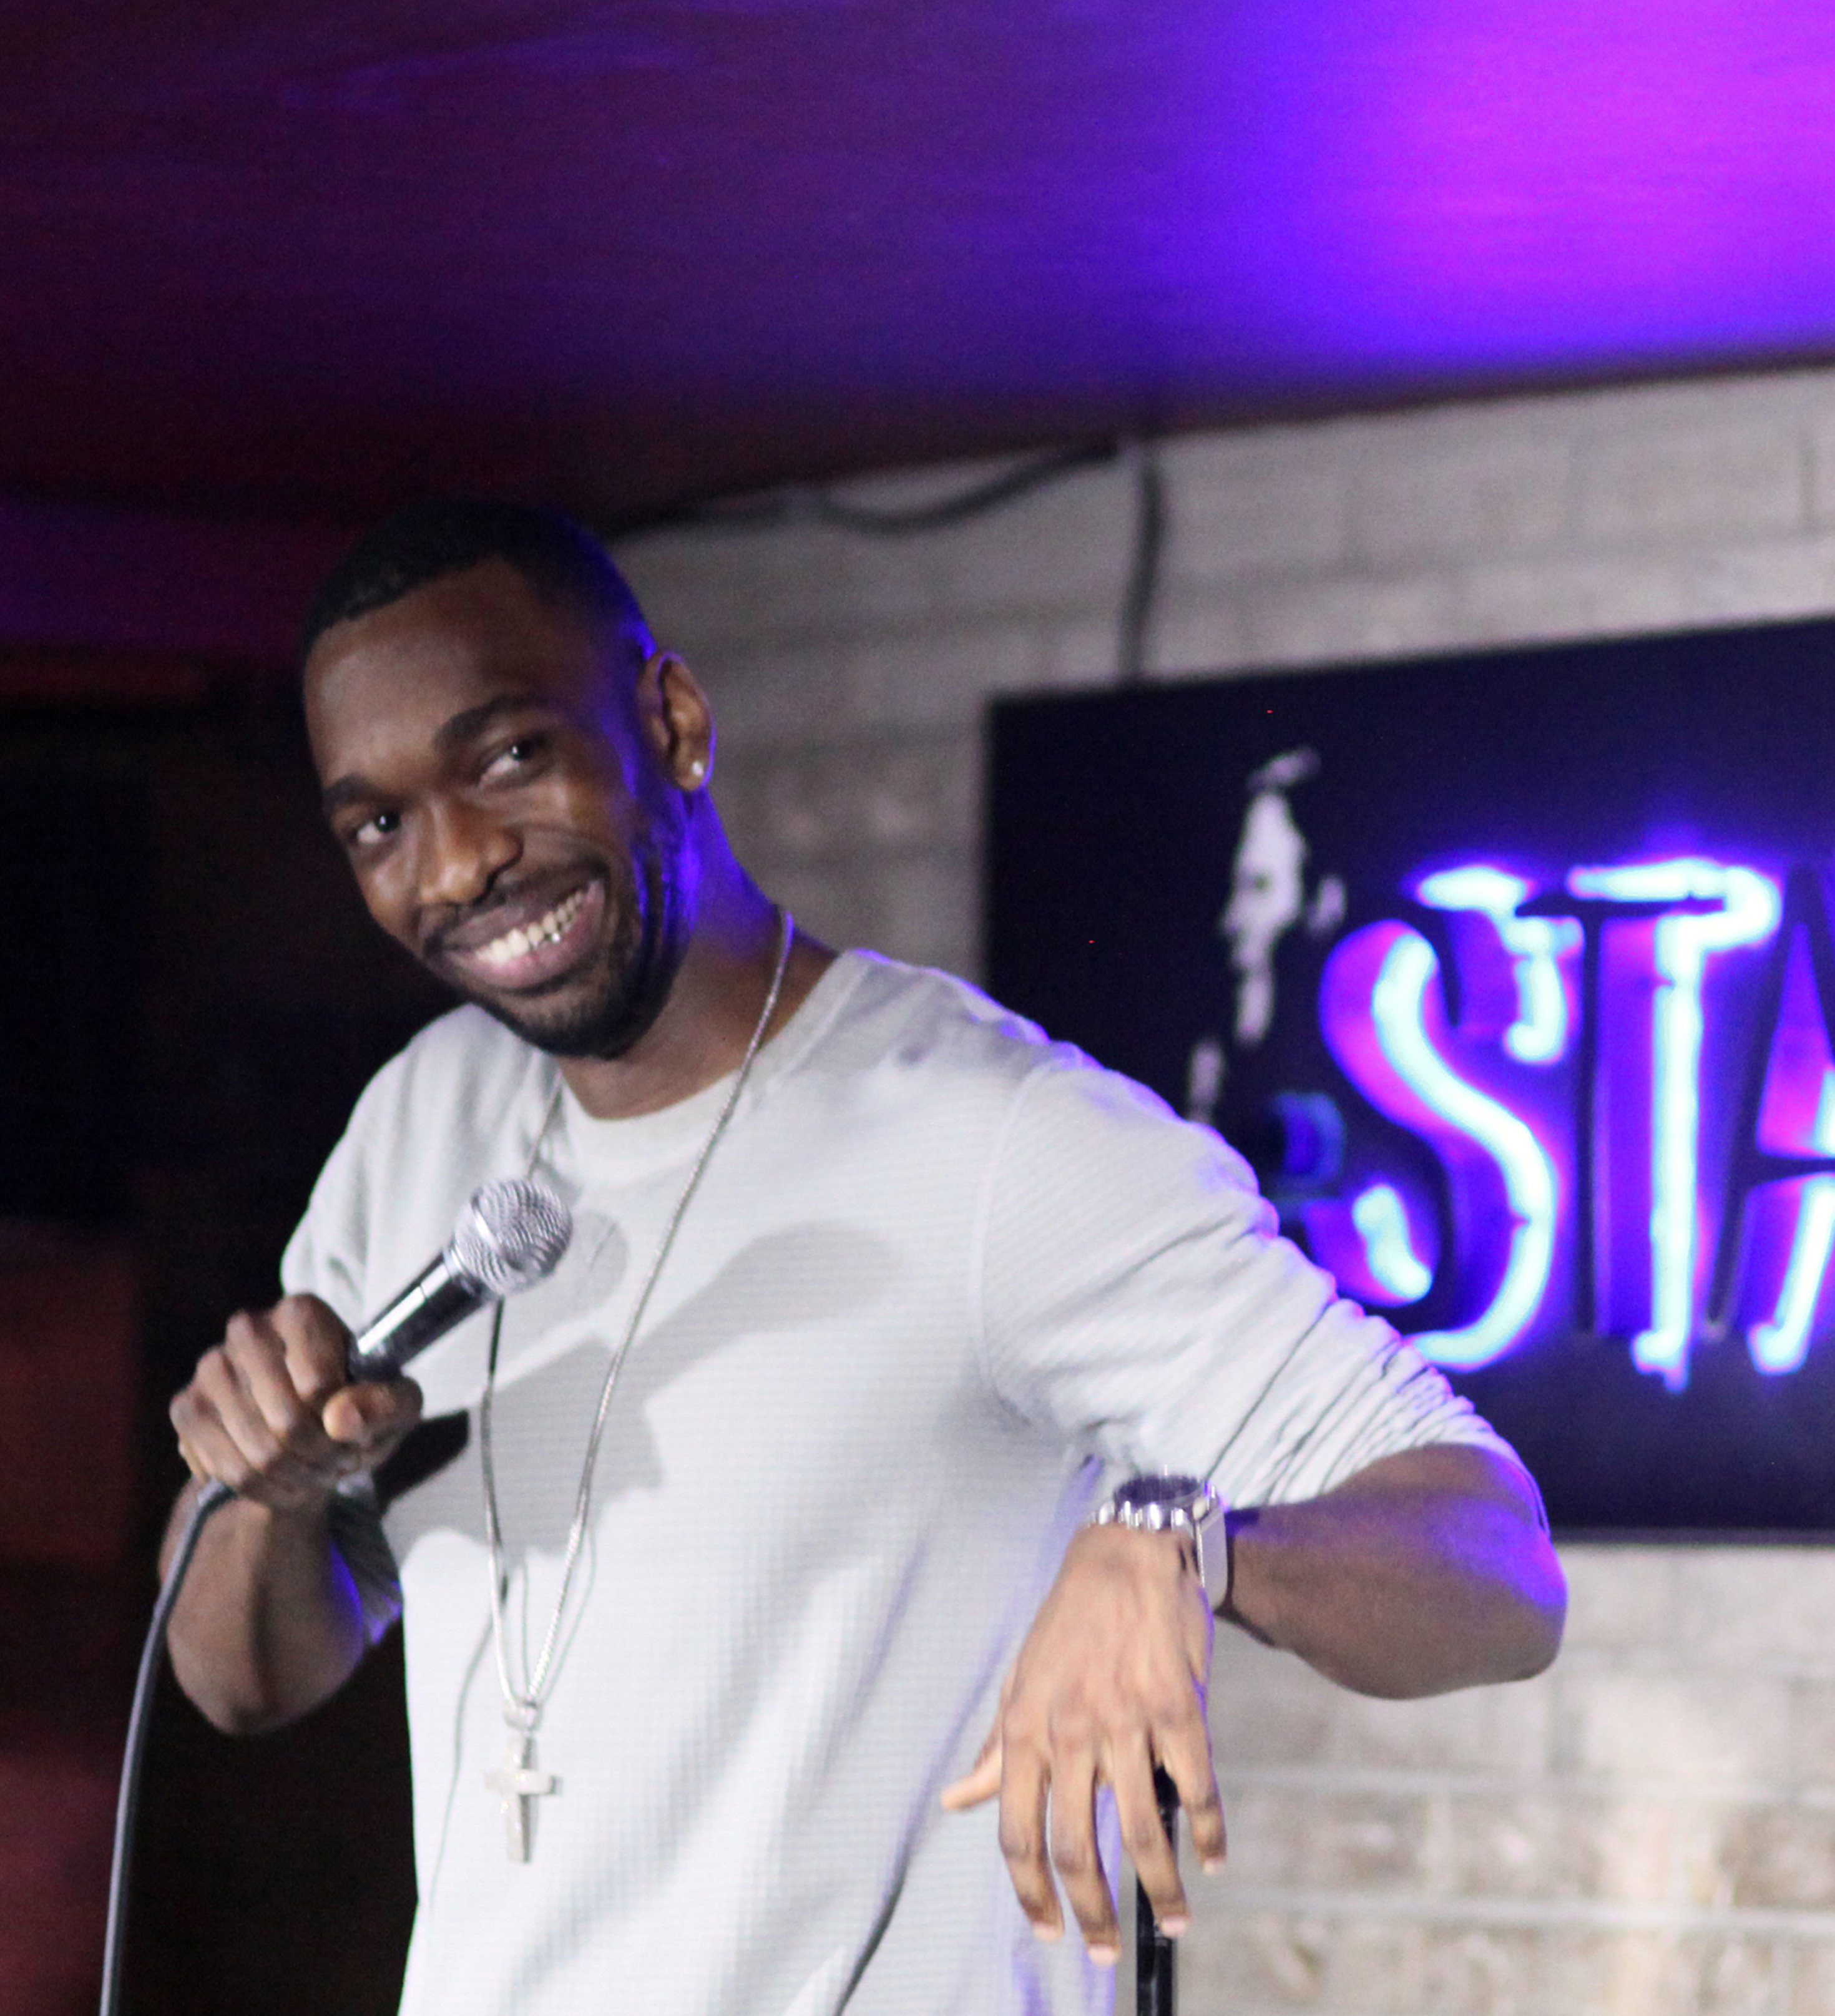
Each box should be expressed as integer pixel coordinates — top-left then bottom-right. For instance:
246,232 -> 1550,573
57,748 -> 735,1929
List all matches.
978,1049 -> 1520,1504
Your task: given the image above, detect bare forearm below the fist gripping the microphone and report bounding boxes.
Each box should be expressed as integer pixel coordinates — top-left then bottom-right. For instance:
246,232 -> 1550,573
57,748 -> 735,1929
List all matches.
161,1484 -> 365,1734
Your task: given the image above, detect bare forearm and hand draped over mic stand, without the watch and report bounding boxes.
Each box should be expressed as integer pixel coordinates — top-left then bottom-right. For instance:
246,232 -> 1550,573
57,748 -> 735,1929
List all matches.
944,1444 -> 1567,1960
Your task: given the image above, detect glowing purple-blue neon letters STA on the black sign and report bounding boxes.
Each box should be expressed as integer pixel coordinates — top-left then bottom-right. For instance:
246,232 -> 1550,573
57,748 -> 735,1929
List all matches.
1307,857 -> 1835,1391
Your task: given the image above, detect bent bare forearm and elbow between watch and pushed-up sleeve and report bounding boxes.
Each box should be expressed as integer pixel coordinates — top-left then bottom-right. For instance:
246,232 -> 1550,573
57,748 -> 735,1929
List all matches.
1226,1446 -> 1567,1700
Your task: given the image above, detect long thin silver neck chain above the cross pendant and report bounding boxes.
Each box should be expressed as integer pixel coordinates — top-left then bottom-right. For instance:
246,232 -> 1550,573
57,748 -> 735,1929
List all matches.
478,908 -> 796,1736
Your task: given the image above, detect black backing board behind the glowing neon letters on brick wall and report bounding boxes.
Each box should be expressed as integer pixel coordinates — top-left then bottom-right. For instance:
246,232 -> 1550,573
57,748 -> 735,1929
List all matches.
986,623 -> 1835,1534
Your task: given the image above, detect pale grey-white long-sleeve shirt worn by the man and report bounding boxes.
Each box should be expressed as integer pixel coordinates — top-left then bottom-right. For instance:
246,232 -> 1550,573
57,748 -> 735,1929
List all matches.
285,954 -> 1502,2016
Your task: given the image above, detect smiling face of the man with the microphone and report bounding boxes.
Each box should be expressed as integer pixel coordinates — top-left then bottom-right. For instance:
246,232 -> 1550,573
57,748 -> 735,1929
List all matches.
306,560 -> 693,1057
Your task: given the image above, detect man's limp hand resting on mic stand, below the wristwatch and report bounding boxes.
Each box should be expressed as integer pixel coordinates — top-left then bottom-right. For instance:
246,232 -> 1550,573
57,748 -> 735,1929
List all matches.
944,1526 -> 1224,1965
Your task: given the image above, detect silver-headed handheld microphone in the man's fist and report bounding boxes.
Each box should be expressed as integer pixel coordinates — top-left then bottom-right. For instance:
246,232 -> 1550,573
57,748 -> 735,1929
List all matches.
345,1175 -> 573,1379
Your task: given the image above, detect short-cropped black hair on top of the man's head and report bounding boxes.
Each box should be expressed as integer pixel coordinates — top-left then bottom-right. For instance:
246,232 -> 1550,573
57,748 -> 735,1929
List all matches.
300,498 -> 653,665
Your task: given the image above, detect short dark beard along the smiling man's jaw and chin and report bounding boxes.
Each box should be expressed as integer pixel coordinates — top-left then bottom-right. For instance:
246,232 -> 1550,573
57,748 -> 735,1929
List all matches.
442,810 -> 690,1060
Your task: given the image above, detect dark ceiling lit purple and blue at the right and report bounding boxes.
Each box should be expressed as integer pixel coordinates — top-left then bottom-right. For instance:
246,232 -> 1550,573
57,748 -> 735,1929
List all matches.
11,0 -> 1835,524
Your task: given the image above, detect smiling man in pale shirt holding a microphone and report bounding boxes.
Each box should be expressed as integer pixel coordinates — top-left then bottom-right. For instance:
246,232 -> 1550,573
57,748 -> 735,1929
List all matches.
172,492 -> 1563,2016
